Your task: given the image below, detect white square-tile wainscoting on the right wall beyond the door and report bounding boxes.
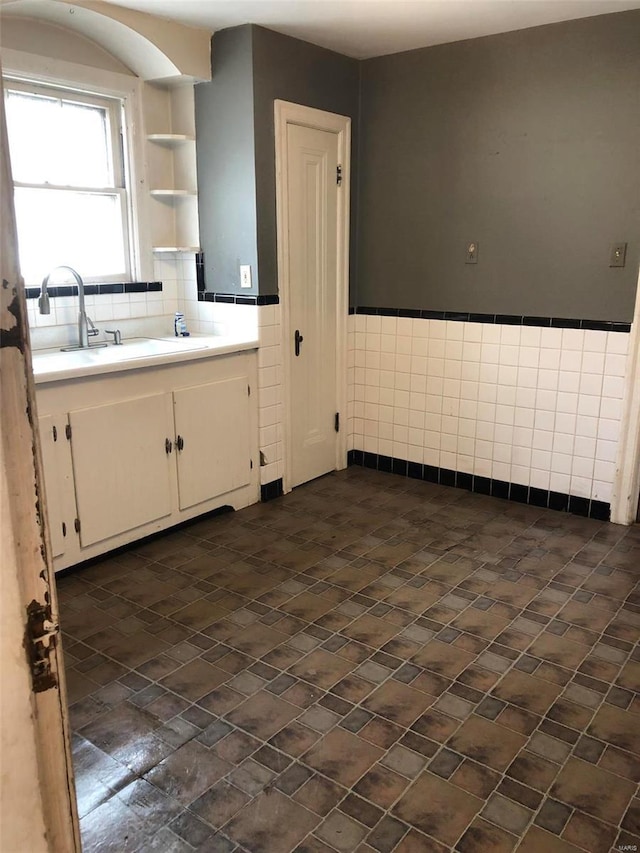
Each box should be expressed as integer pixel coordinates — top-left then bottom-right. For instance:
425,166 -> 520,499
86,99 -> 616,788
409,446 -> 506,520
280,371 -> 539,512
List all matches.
348,314 -> 629,502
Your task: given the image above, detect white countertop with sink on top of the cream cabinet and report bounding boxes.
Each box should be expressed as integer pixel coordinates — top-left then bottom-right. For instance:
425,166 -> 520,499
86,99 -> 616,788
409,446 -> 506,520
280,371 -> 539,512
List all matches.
32,335 -> 258,385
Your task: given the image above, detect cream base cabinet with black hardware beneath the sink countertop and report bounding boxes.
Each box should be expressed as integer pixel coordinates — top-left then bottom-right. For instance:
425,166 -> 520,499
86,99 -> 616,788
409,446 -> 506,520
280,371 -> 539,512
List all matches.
37,352 -> 259,570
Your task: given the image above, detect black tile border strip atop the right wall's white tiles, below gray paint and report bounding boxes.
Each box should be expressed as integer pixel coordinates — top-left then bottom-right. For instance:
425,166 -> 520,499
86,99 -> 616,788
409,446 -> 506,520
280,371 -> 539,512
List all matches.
349,305 -> 631,332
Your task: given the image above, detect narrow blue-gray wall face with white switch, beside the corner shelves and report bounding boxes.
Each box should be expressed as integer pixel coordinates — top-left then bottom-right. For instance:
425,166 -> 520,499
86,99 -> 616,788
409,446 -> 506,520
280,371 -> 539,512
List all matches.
195,25 -> 259,294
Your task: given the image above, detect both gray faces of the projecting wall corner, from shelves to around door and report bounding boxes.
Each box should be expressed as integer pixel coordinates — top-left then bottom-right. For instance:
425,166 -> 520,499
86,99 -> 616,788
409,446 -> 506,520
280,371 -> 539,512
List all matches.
196,24 -> 359,294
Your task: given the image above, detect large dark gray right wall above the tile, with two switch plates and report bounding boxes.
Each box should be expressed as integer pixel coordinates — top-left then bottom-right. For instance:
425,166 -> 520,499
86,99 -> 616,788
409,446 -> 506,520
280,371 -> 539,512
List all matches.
357,12 -> 640,321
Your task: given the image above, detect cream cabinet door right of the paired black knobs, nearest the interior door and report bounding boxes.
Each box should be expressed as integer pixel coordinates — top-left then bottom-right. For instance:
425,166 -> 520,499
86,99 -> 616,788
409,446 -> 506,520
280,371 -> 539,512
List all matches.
173,376 -> 251,510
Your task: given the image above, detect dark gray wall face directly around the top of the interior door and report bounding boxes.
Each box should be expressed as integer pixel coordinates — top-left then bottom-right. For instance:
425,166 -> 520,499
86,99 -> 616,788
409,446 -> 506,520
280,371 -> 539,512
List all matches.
253,27 -> 359,293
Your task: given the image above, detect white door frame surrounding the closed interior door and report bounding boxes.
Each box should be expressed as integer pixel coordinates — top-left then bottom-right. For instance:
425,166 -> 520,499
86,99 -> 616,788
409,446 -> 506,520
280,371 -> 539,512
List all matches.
274,100 -> 351,493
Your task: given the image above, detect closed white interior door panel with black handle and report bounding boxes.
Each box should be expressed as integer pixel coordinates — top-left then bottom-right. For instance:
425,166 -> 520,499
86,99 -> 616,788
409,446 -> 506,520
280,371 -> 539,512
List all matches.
286,124 -> 338,486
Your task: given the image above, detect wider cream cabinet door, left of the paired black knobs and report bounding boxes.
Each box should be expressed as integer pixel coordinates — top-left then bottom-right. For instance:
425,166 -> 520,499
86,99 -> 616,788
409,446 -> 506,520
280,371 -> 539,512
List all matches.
69,394 -> 175,547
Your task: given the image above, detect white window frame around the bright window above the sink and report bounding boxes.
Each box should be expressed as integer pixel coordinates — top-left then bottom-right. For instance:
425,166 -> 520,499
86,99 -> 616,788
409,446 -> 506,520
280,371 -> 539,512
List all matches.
2,49 -> 153,283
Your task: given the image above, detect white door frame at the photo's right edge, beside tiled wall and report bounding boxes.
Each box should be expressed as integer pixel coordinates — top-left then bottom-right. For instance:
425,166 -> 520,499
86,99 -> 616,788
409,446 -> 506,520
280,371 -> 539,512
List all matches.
611,271 -> 640,524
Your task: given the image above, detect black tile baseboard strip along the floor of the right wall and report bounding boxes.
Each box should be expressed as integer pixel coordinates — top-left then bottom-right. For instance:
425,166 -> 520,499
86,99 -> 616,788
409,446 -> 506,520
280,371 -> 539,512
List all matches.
348,450 -> 611,521
